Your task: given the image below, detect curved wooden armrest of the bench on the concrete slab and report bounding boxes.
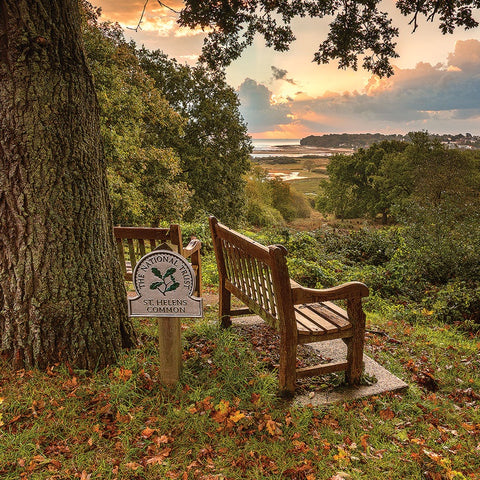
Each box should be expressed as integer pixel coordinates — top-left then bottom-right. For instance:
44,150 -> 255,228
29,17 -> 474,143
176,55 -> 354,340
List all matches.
292,282 -> 368,305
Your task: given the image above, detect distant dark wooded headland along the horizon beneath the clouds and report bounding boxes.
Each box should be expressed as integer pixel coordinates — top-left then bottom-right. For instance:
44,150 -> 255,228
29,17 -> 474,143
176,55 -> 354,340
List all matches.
300,133 -> 480,148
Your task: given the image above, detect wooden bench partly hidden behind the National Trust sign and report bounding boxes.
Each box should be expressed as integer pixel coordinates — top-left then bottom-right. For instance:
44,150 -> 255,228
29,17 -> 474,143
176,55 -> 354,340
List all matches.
113,224 -> 202,297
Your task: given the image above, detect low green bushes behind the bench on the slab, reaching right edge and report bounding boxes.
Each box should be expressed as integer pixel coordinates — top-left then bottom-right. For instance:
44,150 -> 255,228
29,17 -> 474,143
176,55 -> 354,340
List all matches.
251,211 -> 480,331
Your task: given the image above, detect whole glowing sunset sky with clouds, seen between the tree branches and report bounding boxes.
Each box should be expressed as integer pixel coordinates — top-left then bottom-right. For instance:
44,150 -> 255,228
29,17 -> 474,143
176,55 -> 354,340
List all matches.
94,0 -> 480,139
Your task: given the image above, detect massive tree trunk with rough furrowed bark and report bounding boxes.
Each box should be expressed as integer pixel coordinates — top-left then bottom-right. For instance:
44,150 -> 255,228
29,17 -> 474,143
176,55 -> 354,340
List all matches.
0,0 -> 134,369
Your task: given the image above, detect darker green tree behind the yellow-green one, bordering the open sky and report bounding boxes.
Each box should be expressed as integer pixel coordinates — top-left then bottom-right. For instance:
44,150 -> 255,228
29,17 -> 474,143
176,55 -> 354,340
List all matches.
138,48 -> 251,225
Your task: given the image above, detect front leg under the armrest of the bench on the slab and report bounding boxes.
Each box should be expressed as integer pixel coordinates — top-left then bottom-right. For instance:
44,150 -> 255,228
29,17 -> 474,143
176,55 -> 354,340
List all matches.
345,299 -> 365,385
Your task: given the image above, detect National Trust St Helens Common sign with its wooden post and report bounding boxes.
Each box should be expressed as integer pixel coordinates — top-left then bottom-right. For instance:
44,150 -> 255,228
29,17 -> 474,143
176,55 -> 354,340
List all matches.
128,250 -> 203,385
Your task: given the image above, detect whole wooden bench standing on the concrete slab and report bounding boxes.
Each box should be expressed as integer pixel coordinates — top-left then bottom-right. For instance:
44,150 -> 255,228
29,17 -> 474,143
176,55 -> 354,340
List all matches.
210,217 -> 368,394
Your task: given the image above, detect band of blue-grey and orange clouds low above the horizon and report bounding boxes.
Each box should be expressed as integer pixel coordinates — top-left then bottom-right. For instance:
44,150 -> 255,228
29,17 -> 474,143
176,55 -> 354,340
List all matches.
239,40 -> 480,134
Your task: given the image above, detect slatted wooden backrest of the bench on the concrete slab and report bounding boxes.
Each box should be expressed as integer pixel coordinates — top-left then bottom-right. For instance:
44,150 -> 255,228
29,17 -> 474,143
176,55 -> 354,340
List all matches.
210,217 -> 293,329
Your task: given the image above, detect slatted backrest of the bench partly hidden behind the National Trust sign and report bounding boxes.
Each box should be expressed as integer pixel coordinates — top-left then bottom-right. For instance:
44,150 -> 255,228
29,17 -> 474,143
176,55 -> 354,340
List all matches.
113,224 -> 183,280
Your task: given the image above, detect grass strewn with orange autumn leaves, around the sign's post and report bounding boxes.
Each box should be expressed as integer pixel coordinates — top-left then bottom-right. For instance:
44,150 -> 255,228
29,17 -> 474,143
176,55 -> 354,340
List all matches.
0,300 -> 480,480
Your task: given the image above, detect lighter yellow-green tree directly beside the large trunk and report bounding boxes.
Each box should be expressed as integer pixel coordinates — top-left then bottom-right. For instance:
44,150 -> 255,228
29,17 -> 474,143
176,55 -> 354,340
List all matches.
82,2 -> 190,226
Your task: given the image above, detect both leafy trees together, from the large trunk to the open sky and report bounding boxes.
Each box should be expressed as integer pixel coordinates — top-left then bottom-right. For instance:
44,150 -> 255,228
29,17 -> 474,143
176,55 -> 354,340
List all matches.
83,2 -> 255,226
